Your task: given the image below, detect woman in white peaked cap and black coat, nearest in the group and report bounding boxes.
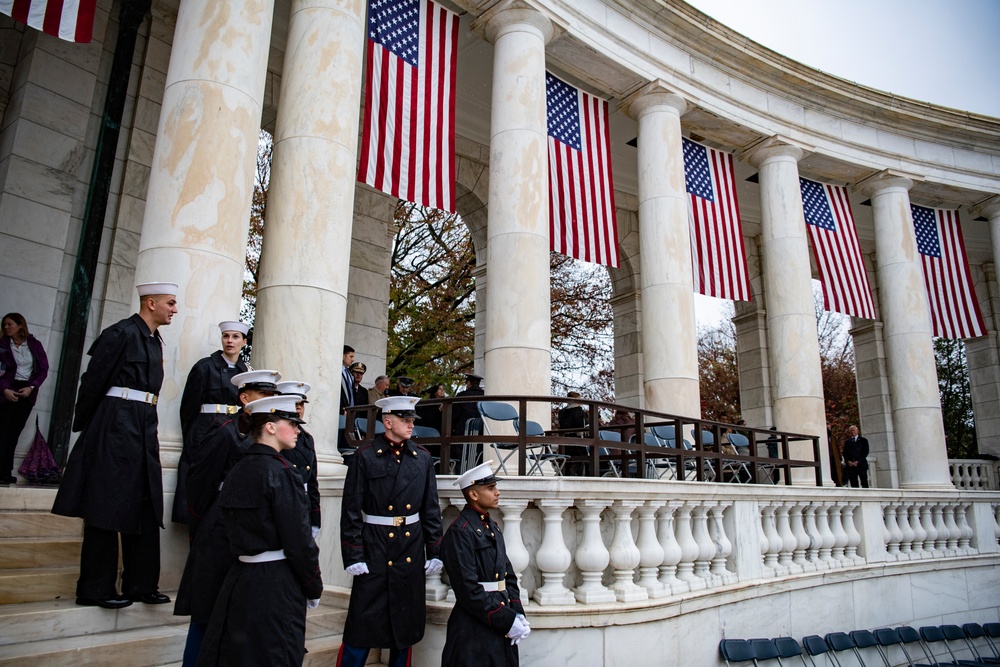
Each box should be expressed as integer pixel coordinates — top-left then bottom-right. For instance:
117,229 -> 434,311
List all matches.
198,395 -> 323,666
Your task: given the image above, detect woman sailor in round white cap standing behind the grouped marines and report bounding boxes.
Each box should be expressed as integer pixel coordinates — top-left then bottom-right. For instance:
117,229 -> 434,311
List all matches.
171,320 -> 250,538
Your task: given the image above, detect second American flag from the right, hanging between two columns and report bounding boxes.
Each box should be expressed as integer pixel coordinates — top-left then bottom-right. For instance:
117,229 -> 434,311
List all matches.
799,178 -> 875,320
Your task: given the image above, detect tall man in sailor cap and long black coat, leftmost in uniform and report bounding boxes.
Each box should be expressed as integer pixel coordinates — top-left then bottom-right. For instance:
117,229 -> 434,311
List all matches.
52,283 -> 177,609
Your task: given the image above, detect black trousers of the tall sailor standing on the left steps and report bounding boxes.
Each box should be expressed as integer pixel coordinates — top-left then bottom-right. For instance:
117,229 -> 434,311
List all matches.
76,496 -> 160,600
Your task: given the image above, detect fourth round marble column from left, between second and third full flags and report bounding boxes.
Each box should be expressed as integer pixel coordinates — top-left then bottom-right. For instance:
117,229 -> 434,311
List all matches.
623,81 -> 701,417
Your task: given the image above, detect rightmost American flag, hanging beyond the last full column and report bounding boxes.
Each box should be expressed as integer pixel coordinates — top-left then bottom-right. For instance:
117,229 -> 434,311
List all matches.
910,204 -> 986,338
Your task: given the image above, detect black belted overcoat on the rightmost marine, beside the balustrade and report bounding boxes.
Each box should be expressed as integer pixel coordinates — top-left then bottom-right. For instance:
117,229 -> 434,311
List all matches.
441,505 -> 524,667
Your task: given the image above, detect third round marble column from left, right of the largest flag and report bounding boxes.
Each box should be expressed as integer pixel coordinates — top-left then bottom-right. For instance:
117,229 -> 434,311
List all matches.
472,3 -> 553,408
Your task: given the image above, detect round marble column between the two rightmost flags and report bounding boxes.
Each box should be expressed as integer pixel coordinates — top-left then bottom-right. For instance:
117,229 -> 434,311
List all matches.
857,172 -> 952,489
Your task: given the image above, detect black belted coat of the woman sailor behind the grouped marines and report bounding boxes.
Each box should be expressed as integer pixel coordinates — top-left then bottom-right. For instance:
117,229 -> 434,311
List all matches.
170,350 -> 247,523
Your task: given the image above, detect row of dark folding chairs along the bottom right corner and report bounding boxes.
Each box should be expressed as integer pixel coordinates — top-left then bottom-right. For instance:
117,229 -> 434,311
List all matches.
719,623 -> 1000,667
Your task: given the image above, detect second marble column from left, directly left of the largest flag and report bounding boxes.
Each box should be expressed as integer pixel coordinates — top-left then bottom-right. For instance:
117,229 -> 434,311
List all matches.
254,0 -> 365,464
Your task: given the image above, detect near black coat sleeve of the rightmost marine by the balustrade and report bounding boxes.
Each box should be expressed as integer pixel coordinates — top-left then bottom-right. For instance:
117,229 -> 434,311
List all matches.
441,516 -> 518,636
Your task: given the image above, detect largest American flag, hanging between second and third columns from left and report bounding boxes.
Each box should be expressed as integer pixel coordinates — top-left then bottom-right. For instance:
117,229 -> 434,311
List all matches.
358,0 -> 458,213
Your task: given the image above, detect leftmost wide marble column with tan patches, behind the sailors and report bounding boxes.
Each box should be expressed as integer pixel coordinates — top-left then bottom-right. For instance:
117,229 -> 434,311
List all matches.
132,0 -> 274,454
